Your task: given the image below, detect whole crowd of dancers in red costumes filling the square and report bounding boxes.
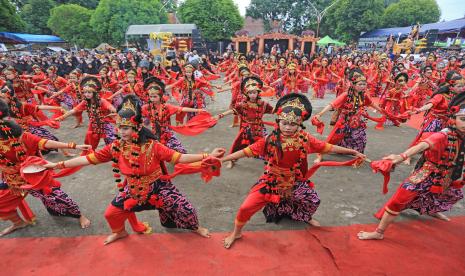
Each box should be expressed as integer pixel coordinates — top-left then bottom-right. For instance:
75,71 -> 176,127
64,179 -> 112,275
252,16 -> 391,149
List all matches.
0,48 -> 465,248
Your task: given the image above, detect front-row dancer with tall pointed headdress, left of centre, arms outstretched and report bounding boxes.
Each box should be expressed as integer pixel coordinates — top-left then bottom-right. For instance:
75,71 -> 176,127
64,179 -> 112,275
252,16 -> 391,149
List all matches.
47,95 -> 224,244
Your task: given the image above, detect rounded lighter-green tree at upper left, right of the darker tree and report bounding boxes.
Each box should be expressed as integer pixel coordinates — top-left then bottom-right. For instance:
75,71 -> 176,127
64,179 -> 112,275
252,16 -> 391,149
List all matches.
47,4 -> 98,47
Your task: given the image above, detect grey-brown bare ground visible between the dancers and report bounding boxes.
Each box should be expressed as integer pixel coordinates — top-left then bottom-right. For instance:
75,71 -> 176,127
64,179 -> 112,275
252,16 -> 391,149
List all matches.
0,78 -> 465,238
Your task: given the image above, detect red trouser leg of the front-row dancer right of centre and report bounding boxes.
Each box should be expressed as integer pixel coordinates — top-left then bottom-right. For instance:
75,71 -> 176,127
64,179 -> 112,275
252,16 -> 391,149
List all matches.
235,184 -> 268,225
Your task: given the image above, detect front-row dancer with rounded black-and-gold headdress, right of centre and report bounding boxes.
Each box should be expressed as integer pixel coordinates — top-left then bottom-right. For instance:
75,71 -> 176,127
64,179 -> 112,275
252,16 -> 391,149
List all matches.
222,93 -> 365,248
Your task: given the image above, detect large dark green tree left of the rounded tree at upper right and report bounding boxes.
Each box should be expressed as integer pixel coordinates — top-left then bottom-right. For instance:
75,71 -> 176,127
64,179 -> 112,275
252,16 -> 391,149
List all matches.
321,0 -> 384,42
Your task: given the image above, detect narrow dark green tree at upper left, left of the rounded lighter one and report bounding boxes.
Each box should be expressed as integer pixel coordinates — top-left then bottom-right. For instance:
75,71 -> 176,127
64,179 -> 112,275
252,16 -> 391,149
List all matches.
20,0 -> 55,34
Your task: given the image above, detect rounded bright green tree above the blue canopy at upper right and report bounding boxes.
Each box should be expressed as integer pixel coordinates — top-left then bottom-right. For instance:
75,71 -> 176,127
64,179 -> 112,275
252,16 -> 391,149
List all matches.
382,0 -> 441,27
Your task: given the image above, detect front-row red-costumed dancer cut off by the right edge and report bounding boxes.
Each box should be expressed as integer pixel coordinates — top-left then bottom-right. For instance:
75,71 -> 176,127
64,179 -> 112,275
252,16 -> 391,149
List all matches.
358,93 -> 465,240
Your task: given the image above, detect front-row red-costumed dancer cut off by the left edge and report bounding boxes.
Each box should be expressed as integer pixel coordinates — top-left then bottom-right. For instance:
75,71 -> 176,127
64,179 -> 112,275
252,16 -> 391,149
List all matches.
0,101 -> 90,236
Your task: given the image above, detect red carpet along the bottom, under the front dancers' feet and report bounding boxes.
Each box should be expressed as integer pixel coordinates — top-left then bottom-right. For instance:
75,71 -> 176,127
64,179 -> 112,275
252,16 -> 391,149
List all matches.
1,217 -> 465,276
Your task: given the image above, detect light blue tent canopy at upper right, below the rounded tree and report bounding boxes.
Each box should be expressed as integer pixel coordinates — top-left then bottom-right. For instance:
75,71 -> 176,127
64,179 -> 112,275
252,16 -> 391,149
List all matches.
360,18 -> 465,38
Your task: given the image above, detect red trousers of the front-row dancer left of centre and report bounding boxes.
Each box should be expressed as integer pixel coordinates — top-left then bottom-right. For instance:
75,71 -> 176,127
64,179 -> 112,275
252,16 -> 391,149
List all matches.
105,204 -> 147,233
